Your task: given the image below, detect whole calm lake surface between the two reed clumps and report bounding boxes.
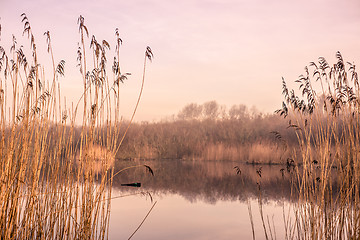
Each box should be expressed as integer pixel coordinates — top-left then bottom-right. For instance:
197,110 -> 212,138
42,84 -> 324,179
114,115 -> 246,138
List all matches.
109,160 -> 291,240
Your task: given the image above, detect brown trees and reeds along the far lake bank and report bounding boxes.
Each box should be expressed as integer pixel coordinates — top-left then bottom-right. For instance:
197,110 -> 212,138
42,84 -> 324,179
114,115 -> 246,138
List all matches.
118,101 -> 296,163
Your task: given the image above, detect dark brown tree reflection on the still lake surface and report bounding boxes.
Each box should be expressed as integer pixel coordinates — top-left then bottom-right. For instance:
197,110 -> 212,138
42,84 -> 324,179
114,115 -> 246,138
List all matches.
113,160 -> 291,203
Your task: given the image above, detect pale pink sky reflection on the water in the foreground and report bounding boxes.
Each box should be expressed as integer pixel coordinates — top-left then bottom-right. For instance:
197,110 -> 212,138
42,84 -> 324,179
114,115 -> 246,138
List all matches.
109,190 -> 289,240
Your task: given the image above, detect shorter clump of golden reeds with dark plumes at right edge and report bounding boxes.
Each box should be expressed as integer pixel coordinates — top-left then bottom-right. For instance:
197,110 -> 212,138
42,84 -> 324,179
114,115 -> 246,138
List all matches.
277,52 -> 360,239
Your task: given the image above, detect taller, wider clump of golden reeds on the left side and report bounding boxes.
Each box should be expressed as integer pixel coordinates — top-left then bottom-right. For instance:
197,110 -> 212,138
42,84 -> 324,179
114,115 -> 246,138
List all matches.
0,14 -> 152,239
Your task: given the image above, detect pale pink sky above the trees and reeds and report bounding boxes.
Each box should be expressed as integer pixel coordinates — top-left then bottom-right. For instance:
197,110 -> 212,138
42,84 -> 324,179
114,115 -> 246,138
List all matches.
0,0 -> 360,121
